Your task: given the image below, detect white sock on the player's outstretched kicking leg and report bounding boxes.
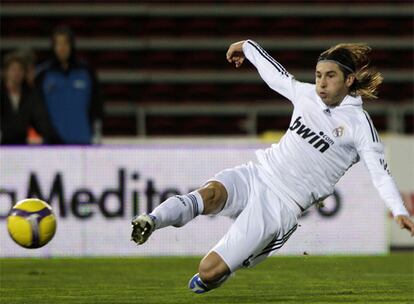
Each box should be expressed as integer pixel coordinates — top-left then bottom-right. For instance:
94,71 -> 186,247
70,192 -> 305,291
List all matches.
150,191 -> 204,229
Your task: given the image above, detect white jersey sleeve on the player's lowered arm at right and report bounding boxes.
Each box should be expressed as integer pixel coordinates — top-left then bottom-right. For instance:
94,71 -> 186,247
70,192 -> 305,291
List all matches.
355,112 -> 409,216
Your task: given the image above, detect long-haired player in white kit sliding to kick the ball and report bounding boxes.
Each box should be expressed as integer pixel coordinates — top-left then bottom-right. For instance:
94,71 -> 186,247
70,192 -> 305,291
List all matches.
132,40 -> 414,293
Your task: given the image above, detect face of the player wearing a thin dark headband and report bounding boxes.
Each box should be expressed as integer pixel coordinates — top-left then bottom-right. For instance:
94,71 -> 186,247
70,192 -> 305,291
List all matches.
315,61 -> 352,106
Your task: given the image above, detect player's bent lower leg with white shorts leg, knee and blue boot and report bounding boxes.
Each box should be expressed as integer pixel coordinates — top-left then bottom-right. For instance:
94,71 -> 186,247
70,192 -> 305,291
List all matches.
189,171 -> 300,293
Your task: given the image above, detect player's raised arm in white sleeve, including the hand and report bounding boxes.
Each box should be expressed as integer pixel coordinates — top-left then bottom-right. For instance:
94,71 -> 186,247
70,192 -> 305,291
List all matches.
226,40 -> 301,103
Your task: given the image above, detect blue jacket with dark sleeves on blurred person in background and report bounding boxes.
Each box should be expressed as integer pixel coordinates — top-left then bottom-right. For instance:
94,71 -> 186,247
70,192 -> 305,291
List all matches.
37,60 -> 102,144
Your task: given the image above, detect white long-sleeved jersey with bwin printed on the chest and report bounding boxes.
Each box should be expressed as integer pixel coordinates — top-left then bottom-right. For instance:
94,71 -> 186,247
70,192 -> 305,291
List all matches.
243,40 -> 408,216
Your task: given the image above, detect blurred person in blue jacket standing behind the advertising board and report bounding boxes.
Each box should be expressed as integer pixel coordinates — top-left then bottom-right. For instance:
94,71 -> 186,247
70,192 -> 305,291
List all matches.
36,27 -> 102,144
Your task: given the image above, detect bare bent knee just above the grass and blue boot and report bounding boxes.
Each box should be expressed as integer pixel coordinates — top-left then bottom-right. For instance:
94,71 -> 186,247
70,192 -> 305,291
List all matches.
198,252 -> 230,283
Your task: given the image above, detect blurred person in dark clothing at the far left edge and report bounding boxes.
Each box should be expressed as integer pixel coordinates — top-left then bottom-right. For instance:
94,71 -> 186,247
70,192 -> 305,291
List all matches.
0,52 -> 58,144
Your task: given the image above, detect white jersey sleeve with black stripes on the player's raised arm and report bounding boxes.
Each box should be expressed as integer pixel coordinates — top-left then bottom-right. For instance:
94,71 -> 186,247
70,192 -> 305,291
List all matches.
243,40 -> 300,103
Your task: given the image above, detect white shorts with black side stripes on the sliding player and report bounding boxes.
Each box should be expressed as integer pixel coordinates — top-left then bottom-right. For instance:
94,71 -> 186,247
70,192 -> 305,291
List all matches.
210,162 -> 297,272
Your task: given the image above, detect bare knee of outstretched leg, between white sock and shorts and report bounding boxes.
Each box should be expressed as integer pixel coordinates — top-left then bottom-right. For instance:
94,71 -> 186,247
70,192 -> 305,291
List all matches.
198,181 -> 227,214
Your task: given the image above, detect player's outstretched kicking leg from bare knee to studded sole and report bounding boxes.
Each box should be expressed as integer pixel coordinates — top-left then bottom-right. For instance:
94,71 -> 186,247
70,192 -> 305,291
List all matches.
132,181 -> 227,244
